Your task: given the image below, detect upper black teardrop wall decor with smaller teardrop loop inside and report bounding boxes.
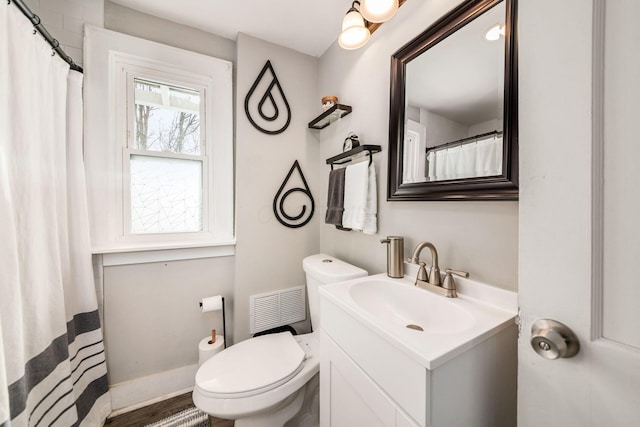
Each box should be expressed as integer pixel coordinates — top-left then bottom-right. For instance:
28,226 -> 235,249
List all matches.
244,61 -> 291,135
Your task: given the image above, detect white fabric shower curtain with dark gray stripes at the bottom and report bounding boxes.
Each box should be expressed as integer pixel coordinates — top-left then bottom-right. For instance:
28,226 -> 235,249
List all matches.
0,3 -> 111,427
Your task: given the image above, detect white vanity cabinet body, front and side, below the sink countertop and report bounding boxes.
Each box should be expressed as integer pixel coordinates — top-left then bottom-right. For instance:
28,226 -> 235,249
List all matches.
320,276 -> 517,427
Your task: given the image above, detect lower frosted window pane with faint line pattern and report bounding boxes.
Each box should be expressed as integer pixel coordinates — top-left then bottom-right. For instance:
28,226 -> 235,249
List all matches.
130,155 -> 202,234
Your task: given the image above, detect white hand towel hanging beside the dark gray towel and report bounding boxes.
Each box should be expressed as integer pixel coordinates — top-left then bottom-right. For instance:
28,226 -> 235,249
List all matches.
342,161 -> 378,234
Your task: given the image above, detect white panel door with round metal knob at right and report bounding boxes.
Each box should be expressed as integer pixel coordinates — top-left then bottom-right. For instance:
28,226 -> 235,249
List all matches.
518,0 -> 640,427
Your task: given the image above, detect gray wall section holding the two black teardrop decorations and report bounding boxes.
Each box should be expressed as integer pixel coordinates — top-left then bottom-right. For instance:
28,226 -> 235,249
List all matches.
234,34 -> 326,341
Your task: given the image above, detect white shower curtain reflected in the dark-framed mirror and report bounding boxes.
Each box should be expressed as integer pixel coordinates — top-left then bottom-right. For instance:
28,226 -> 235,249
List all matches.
427,136 -> 502,181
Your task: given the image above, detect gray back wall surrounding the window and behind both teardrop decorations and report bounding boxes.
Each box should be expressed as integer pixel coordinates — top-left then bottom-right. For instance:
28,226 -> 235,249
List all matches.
99,2 -> 321,384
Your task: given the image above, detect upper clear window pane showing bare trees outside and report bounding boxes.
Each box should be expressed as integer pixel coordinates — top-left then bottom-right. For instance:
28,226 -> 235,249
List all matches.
133,79 -> 200,155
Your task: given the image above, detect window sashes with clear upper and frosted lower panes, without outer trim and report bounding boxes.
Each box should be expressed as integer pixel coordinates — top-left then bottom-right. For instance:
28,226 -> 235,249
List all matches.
129,78 -> 207,234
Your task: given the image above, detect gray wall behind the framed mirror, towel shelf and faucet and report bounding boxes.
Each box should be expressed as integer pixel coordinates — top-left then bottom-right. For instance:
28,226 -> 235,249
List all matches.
318,0 -> 518,290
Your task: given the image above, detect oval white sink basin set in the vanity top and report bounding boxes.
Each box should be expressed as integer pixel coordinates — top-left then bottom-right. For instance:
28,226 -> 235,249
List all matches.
349,279 -> 475,334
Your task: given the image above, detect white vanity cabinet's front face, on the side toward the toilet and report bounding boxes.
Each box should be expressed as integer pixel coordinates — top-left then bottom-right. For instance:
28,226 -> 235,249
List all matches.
320,301 -> 428,427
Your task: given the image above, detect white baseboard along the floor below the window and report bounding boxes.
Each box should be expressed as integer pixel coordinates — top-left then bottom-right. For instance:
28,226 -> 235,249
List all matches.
109,363 -> 198,417
